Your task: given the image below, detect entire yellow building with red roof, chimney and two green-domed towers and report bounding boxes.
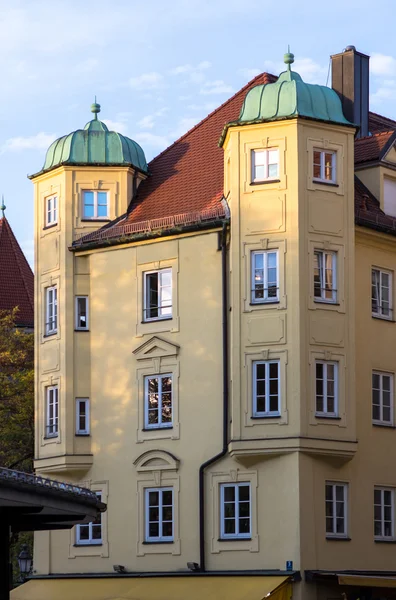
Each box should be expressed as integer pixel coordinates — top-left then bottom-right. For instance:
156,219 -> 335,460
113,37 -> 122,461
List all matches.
27,47 -> 396,600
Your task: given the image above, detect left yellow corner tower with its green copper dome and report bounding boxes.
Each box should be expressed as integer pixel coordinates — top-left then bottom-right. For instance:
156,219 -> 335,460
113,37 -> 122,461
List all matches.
30,102 -> 148,479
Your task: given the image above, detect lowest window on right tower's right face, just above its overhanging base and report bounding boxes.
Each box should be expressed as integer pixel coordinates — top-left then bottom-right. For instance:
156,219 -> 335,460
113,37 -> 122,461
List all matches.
315,360 -> 338,417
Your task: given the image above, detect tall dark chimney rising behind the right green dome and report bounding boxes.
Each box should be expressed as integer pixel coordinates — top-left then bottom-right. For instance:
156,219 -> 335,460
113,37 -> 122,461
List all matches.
331,46 -> 370,137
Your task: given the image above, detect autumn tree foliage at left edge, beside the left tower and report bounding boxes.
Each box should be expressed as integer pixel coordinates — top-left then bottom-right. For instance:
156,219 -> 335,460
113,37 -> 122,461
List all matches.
0,309 -> 34,472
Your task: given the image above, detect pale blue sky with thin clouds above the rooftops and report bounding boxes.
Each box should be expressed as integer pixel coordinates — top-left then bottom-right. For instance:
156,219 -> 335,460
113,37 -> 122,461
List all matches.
0,0 -> 396,262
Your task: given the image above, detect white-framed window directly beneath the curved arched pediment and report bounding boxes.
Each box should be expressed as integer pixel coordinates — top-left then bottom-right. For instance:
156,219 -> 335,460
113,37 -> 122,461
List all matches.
145,488 -> 173,542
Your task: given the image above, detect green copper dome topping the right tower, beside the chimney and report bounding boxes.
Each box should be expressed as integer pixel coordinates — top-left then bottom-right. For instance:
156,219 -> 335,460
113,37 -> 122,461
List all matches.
238,52 -> 353,125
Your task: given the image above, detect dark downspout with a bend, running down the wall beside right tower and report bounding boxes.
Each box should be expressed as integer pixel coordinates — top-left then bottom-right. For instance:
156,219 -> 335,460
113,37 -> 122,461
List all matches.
199,223 -> 228,572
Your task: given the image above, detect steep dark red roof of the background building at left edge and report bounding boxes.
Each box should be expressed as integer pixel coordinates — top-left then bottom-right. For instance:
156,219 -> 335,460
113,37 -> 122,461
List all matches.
0,217 -> 34,327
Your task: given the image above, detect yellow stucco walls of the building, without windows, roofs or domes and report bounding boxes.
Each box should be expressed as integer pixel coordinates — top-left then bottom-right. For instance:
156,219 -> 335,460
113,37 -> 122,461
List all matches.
34,97 -> 396,599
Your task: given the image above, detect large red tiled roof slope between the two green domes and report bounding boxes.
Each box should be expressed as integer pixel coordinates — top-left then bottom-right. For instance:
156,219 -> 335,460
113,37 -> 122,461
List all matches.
126,73 -> 276,223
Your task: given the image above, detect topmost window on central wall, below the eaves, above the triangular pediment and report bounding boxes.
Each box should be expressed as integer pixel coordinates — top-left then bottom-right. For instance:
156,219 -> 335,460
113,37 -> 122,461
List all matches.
143,269 -> 172,321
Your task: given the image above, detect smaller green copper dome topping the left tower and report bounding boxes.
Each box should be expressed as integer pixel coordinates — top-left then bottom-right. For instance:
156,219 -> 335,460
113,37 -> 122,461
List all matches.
42,102 -> 147,172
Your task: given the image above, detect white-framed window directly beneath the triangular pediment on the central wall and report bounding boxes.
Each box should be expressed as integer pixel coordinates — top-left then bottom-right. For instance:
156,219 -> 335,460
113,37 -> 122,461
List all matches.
144,374 -> 172,429
